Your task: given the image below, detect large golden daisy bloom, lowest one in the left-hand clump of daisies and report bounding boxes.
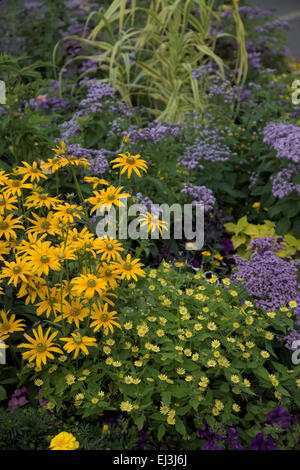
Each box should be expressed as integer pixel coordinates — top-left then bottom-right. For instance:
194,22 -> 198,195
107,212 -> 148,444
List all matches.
18,325 -> 63,367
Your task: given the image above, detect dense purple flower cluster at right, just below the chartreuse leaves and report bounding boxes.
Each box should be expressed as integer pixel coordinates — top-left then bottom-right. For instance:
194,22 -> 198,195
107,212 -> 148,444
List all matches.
232,237 -> 300,324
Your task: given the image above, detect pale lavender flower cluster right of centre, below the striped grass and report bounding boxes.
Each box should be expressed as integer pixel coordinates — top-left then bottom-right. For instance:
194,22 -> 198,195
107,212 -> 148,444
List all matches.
179,125 -> 237,170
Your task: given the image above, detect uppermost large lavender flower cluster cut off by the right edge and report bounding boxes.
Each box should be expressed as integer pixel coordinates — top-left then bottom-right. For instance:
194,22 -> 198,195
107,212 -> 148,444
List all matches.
263,122 -> 300,163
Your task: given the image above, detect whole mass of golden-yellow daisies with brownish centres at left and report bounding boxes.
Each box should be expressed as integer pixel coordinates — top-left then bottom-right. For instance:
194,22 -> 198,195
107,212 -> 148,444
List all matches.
0,142 -> 153,366
